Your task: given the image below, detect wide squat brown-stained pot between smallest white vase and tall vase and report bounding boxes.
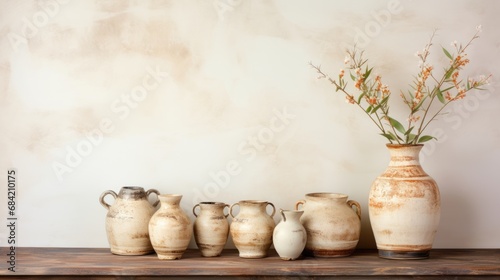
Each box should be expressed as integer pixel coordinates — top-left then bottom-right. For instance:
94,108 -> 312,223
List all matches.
295,193 -> 361,257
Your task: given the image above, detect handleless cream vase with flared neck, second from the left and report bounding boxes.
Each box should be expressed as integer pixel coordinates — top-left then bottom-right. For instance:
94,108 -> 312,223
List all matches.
149,194 -> 193,260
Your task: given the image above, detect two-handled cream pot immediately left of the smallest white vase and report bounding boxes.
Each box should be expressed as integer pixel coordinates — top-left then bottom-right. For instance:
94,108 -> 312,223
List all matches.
229,200 -> 276,258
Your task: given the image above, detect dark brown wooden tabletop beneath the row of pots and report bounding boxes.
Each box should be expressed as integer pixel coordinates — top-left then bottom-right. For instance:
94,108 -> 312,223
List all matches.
0,248 -> 500,279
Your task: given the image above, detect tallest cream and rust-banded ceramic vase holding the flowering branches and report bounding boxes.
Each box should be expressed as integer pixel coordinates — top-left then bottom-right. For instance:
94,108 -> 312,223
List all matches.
369,144 -> 440,259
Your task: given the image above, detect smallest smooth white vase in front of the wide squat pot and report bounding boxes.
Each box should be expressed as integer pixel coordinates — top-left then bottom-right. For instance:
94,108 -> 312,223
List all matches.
273,210 -> 307,261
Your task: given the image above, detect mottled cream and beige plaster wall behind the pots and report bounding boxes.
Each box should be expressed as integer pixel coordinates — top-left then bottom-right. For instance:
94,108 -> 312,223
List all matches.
0,0 -> 500,248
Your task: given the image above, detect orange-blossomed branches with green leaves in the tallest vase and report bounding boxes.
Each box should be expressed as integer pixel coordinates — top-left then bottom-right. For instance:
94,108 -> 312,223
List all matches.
310,26 -> 491,144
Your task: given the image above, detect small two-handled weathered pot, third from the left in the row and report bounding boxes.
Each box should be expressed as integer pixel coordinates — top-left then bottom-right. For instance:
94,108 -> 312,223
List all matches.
193,202 -> 229,257
